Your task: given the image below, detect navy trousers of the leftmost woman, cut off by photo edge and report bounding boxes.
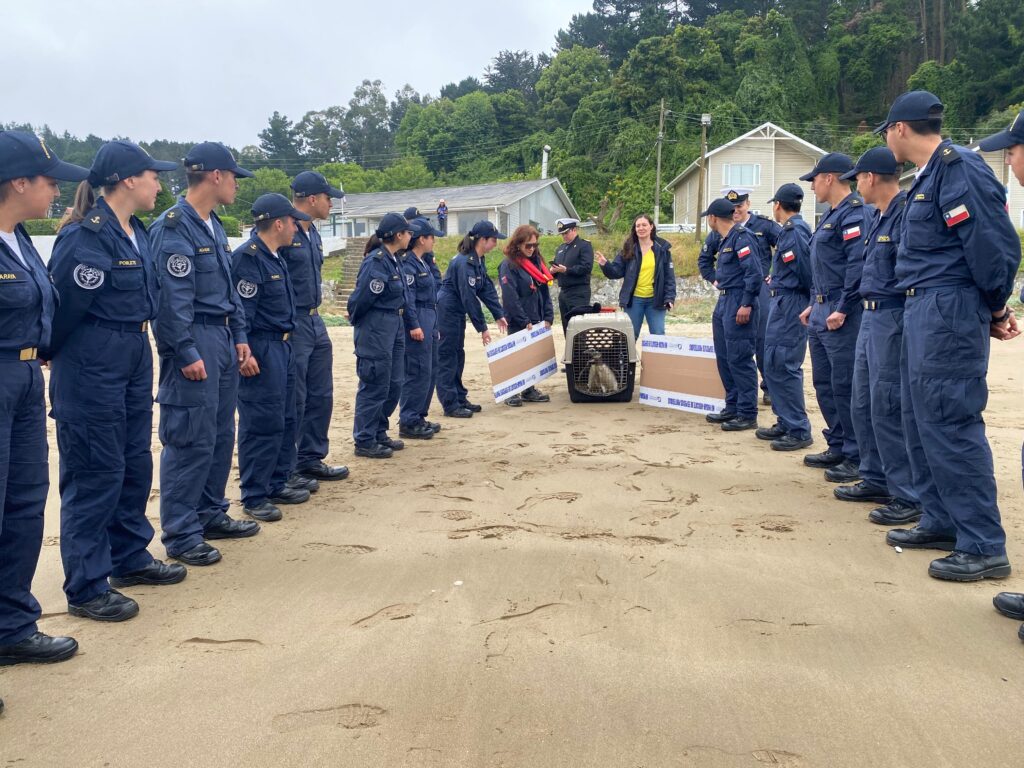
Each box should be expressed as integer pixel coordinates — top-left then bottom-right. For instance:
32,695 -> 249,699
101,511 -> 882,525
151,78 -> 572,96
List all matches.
0,360 -> 50,644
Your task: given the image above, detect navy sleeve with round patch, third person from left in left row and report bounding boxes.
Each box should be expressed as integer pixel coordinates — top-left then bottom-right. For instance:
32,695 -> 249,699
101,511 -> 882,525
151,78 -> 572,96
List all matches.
151,222 -> 202,368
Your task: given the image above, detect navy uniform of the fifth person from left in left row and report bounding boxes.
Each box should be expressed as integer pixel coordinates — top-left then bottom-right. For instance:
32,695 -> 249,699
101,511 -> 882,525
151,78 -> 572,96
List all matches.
281,223 -> 334,471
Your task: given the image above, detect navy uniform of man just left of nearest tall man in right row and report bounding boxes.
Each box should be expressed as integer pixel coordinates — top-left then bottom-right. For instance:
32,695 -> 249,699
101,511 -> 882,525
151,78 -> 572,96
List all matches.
853,191 -> 918,504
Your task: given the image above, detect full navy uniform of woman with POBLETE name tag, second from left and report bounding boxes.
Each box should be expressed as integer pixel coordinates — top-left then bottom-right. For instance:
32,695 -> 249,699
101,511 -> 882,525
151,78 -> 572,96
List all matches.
49,198 -> 158,604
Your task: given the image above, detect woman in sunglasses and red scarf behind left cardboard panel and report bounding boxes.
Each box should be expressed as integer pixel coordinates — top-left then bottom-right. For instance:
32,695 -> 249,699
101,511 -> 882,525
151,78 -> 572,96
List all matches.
498,224 -> 555,408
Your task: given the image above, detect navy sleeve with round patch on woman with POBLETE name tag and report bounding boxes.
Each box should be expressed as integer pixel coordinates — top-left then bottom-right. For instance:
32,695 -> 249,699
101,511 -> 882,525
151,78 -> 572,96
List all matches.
48,228 -> 112,356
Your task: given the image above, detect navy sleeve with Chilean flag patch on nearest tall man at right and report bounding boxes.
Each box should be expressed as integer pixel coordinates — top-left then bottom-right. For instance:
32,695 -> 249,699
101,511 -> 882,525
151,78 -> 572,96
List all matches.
939,159 -> 1021,312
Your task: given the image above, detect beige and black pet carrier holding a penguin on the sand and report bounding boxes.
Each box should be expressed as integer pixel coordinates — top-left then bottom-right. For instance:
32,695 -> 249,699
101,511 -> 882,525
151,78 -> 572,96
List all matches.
563,304 -> 637,402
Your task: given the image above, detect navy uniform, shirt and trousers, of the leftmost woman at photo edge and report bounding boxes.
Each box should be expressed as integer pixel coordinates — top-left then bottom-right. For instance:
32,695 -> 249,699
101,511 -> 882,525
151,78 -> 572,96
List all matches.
0,224 -> 57,645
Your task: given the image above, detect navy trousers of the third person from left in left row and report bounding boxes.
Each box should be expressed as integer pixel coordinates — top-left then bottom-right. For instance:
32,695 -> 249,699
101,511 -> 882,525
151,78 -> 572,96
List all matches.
157,324 -> 239,557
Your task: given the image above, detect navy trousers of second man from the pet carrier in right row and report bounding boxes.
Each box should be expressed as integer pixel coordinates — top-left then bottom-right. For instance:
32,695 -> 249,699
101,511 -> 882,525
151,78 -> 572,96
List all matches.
762,293 -> 811,438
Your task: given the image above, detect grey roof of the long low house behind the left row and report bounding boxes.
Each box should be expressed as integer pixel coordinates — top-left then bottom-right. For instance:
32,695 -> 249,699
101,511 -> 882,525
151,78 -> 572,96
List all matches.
339,178 -> 580,218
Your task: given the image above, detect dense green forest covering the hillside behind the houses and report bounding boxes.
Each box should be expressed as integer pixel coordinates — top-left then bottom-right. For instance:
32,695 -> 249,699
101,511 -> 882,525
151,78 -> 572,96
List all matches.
6,0 -> 1024,228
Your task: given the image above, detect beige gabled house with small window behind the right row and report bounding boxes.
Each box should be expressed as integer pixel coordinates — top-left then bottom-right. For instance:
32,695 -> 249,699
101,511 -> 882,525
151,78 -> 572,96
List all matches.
665,123 -> 826,226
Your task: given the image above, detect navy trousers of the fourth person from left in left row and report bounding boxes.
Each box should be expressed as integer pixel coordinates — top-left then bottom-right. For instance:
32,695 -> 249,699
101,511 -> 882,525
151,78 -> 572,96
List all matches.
239,334 -> 297,507
